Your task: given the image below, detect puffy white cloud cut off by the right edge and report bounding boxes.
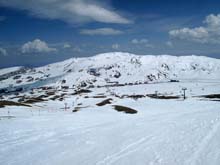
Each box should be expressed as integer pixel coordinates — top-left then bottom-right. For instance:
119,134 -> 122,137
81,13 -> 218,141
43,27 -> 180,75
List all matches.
169,14 -> 220,44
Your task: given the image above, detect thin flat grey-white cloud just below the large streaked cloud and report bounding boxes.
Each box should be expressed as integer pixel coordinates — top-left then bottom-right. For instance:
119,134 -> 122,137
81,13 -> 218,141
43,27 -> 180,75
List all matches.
80,28 -> 123,35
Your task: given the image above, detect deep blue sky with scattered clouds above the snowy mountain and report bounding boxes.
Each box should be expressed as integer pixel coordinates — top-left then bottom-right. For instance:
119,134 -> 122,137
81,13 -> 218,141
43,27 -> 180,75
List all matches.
0,0 -> 220,68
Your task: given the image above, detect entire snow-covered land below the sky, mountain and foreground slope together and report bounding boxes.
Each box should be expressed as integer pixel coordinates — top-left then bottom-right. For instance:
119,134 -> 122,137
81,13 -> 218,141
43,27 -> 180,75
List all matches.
0,53 -> 220,165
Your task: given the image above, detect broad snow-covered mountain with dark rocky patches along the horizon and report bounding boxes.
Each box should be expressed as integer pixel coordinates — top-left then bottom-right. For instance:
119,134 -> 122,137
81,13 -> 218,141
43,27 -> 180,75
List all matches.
0,52 -> 220,89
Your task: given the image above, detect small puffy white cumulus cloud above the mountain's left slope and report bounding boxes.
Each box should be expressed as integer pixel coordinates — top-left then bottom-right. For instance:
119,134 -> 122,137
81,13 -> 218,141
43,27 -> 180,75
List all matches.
21,39 -> 57,53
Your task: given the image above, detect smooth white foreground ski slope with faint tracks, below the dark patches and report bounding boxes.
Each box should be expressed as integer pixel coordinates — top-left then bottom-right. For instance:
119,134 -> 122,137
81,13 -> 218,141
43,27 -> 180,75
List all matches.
0,99 -> 220,165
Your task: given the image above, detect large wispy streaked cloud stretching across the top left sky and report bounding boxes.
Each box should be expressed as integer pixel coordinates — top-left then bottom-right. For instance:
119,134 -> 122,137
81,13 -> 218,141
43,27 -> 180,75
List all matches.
0,0 -> 131,24
